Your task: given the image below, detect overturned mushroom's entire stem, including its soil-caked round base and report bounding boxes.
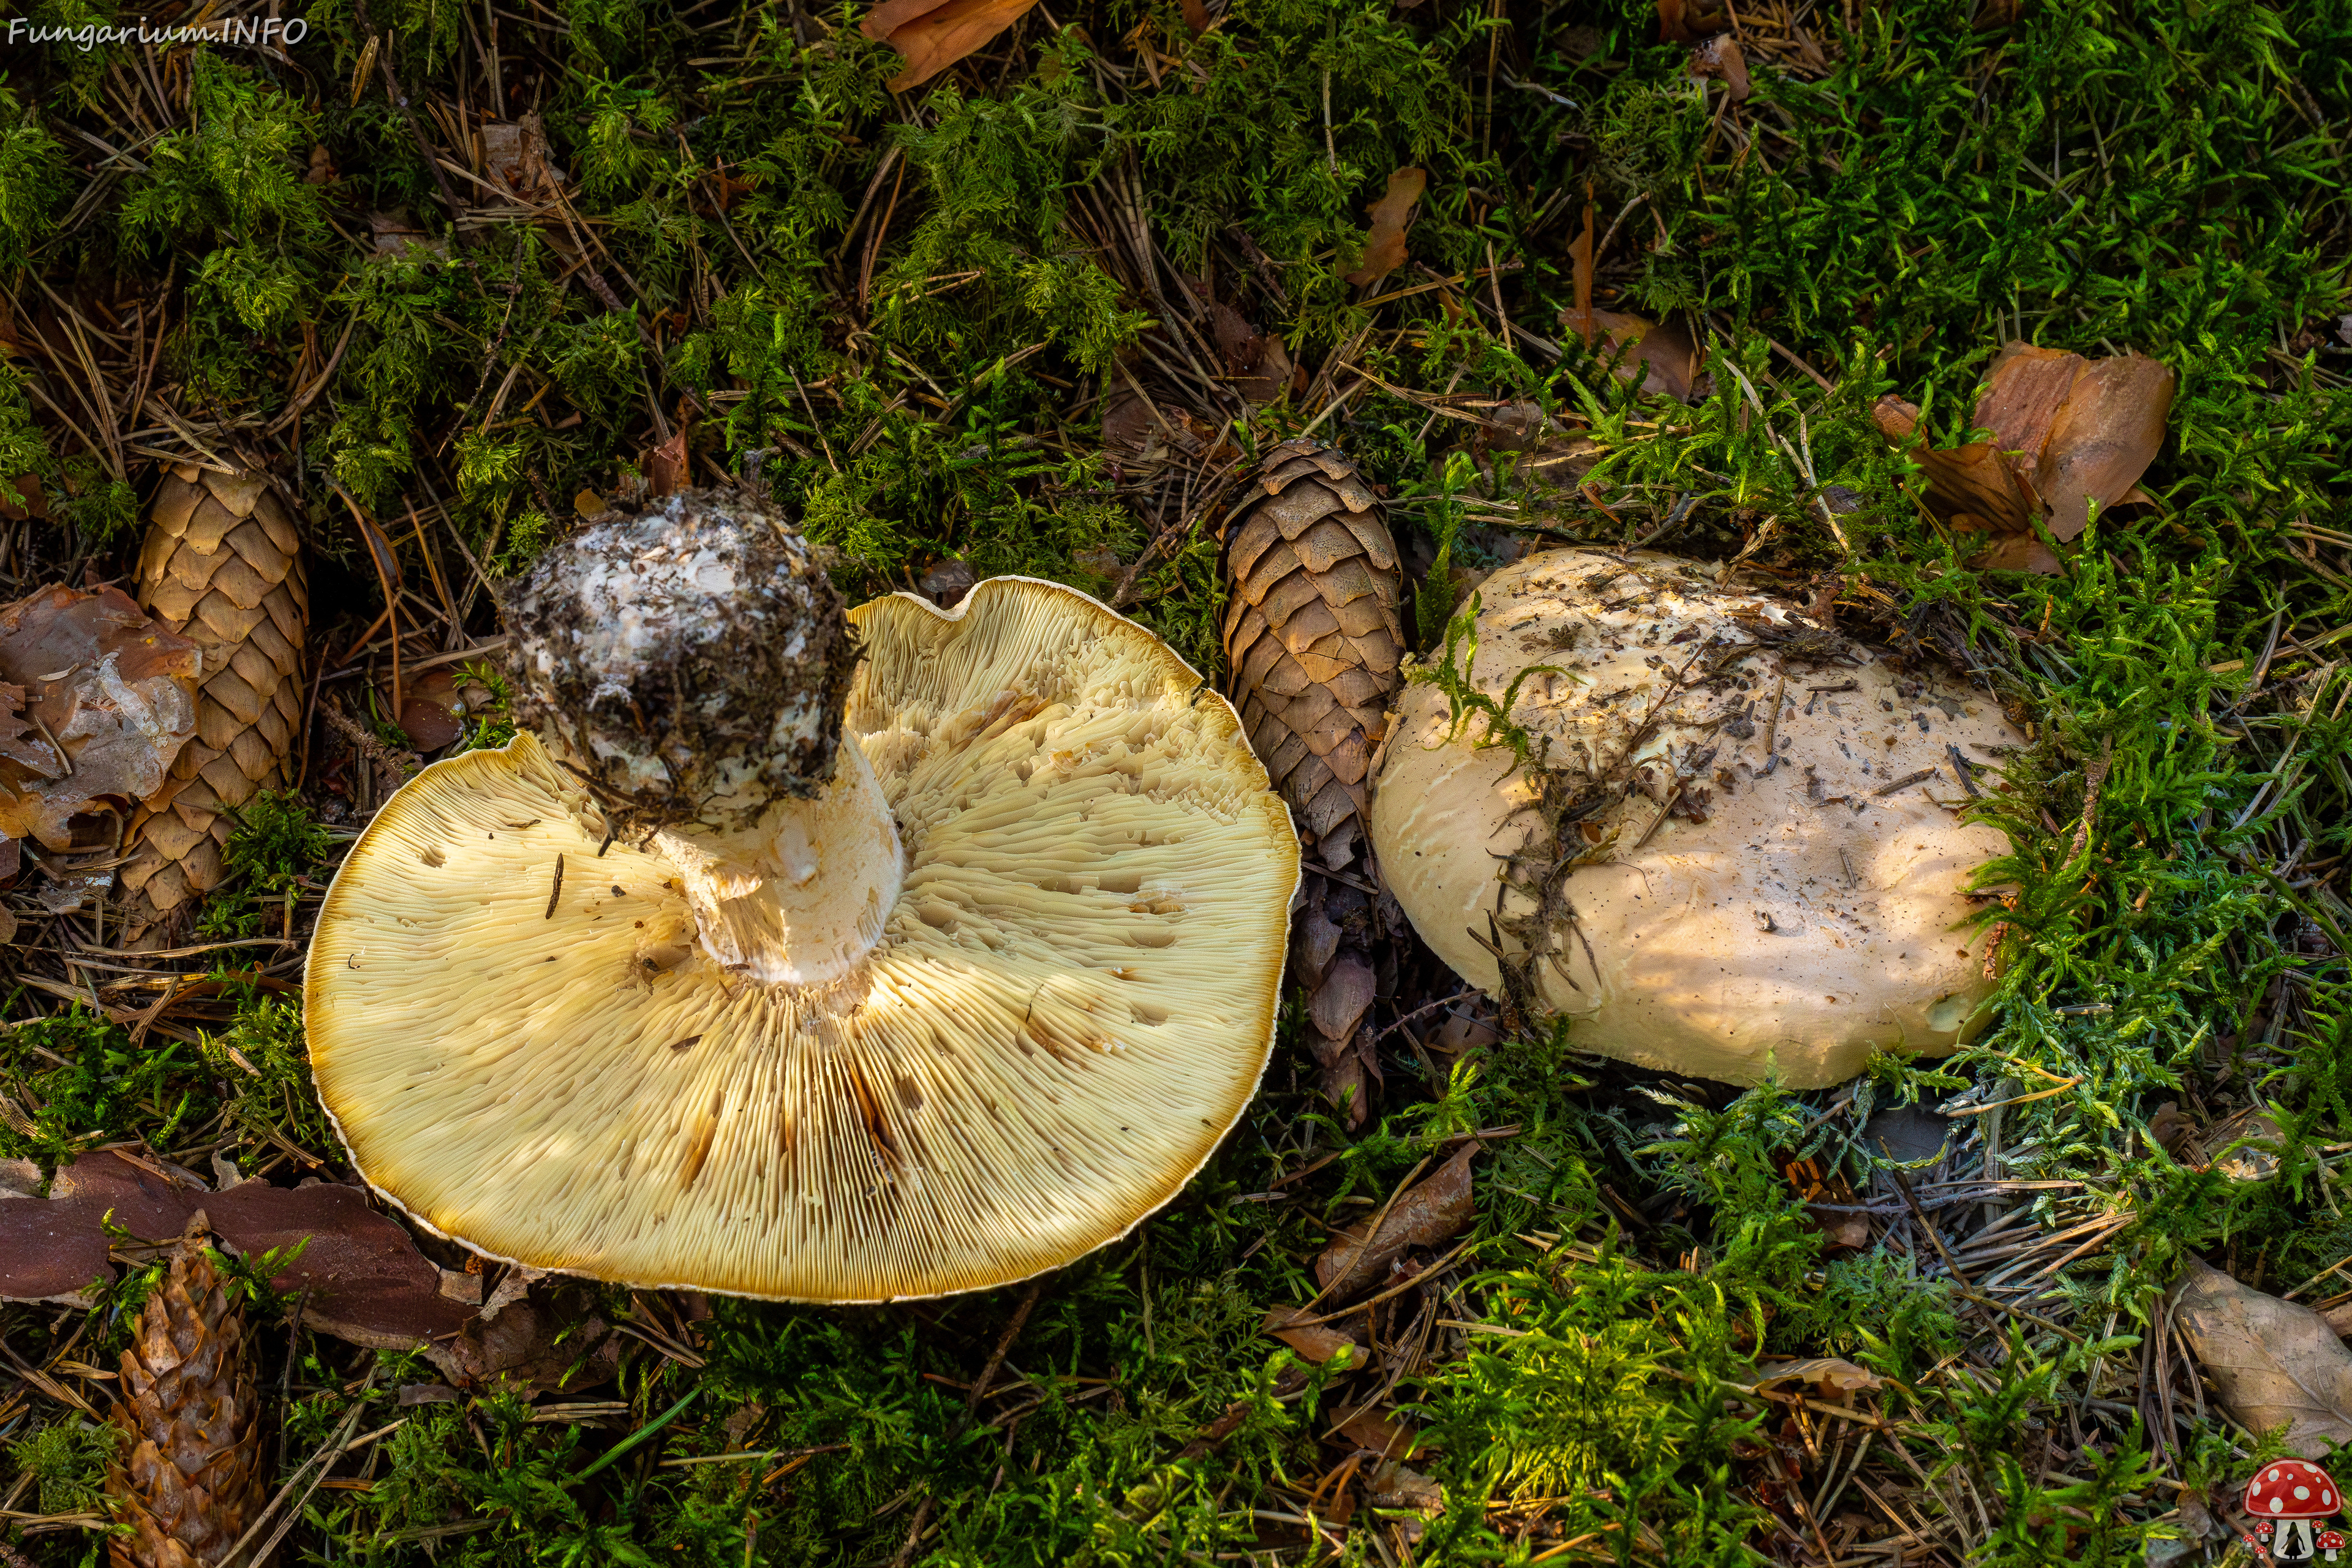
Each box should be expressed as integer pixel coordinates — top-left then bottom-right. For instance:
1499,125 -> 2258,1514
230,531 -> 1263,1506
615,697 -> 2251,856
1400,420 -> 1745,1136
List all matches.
506,491 -> 884,985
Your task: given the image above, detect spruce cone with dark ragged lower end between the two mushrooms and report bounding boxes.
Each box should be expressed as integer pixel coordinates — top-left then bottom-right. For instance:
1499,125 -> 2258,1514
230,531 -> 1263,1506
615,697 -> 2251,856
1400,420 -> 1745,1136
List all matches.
1226,442 -> 1404,1124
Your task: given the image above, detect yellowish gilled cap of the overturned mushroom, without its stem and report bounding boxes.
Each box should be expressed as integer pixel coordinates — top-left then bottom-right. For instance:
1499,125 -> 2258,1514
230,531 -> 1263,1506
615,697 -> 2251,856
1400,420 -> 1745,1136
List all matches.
306,578 -> 1298,1302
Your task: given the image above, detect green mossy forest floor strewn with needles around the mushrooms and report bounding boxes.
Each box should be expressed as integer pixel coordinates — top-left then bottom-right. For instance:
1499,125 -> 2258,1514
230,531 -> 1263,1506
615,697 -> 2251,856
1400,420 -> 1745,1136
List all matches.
0,0 -> 2352,1568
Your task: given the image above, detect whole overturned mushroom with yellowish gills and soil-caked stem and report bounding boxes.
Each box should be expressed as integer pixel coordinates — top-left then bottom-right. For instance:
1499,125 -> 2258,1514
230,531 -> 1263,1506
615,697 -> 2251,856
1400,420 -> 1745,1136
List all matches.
306,491 -> 1298,1302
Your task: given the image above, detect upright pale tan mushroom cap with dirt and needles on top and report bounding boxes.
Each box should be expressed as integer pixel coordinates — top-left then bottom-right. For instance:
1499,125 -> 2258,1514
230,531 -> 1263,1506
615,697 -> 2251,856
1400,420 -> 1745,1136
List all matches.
1371,550 -> 2022,1088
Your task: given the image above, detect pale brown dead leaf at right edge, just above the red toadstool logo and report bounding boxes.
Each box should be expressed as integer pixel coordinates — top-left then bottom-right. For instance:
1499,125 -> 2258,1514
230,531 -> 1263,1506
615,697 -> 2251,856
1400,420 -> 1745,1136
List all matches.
2173,1257 -> 2352,1460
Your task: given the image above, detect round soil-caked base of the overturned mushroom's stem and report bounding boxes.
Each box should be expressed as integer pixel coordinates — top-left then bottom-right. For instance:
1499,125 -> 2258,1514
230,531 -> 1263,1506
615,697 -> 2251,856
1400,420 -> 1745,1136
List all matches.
508,491 -> 856,837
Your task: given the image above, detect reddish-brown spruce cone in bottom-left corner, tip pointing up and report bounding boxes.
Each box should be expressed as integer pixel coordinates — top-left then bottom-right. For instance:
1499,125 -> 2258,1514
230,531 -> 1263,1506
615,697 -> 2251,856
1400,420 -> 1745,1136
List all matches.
106,1213 -> 263,1568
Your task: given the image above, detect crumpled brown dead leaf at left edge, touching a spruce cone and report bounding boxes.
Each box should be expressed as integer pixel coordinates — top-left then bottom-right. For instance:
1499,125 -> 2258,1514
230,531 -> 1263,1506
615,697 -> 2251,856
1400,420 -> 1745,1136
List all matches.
0,588 -> 200,851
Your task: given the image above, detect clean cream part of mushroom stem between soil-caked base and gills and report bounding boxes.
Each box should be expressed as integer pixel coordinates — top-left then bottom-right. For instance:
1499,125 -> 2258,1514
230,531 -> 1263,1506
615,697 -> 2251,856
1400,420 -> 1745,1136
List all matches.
654,736 -> 905,985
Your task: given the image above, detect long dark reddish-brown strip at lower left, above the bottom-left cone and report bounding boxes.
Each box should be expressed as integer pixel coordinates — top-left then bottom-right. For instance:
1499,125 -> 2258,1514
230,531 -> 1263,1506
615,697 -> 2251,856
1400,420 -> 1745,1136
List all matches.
0,1152 -> 473,1349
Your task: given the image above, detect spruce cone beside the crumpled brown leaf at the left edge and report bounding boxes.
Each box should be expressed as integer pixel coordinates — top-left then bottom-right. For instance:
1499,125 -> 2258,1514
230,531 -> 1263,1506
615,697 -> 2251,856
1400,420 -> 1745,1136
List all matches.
123,466 -> 311,936
